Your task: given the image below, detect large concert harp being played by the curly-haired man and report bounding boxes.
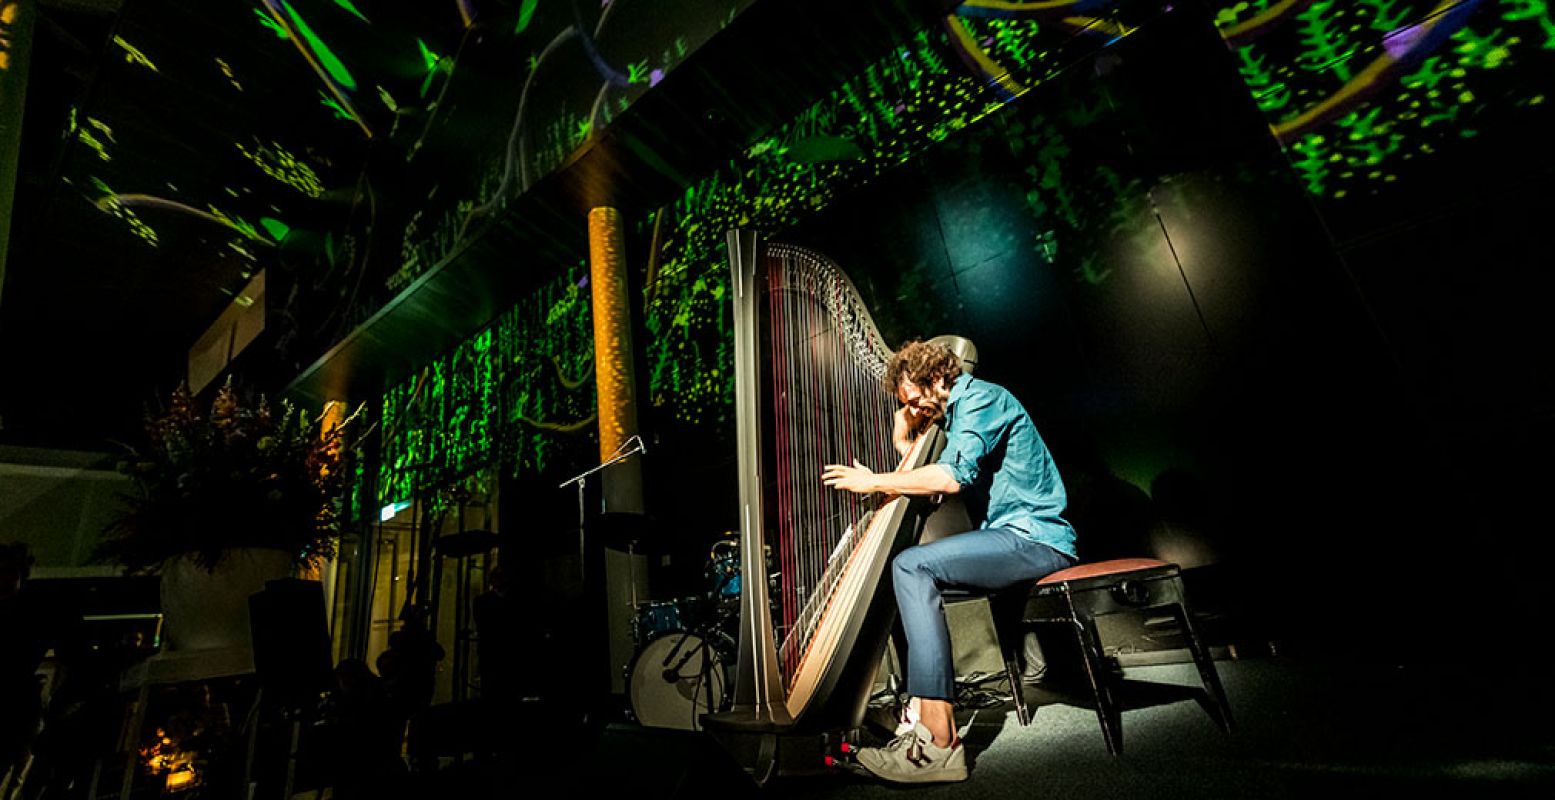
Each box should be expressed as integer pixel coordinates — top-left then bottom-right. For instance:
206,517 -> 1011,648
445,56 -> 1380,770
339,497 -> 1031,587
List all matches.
704,230 -> 975,780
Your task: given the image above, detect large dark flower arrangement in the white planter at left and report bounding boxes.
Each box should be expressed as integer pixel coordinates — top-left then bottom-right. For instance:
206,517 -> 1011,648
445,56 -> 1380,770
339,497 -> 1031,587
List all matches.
96,380 -> 361,573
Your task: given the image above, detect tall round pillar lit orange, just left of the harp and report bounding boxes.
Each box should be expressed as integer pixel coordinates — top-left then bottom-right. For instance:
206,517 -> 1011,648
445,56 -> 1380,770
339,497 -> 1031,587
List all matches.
588,207 -> 650,693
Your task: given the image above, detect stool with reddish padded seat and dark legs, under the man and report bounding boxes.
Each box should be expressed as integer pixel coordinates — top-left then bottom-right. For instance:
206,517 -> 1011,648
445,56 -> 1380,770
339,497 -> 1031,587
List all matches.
1026,559 -> 1232,755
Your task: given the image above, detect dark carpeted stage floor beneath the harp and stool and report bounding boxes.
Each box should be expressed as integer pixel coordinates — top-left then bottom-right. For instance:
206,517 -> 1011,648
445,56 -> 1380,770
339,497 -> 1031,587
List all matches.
312,655 -> 1555,800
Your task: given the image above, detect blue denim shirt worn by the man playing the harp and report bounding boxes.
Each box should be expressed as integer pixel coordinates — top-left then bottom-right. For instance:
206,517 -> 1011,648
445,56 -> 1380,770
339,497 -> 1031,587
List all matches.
938,375 -> 1075,556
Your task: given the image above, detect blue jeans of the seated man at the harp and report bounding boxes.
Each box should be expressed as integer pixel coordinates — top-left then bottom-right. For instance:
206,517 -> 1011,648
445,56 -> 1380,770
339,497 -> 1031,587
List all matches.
891,528 -> 1075,702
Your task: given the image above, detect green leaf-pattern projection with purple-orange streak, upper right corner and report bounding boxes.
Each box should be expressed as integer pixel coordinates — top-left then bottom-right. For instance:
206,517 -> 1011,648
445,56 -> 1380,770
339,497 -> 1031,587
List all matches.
1216,0 -> 1555,199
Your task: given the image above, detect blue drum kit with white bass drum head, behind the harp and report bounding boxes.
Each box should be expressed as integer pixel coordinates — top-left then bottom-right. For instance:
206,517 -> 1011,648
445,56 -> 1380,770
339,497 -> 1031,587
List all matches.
627,529 -> 765,730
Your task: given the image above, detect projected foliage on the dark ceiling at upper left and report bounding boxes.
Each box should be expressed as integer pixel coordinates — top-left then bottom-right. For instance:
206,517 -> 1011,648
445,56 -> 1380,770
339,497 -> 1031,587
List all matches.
39,0 -> 750,398
